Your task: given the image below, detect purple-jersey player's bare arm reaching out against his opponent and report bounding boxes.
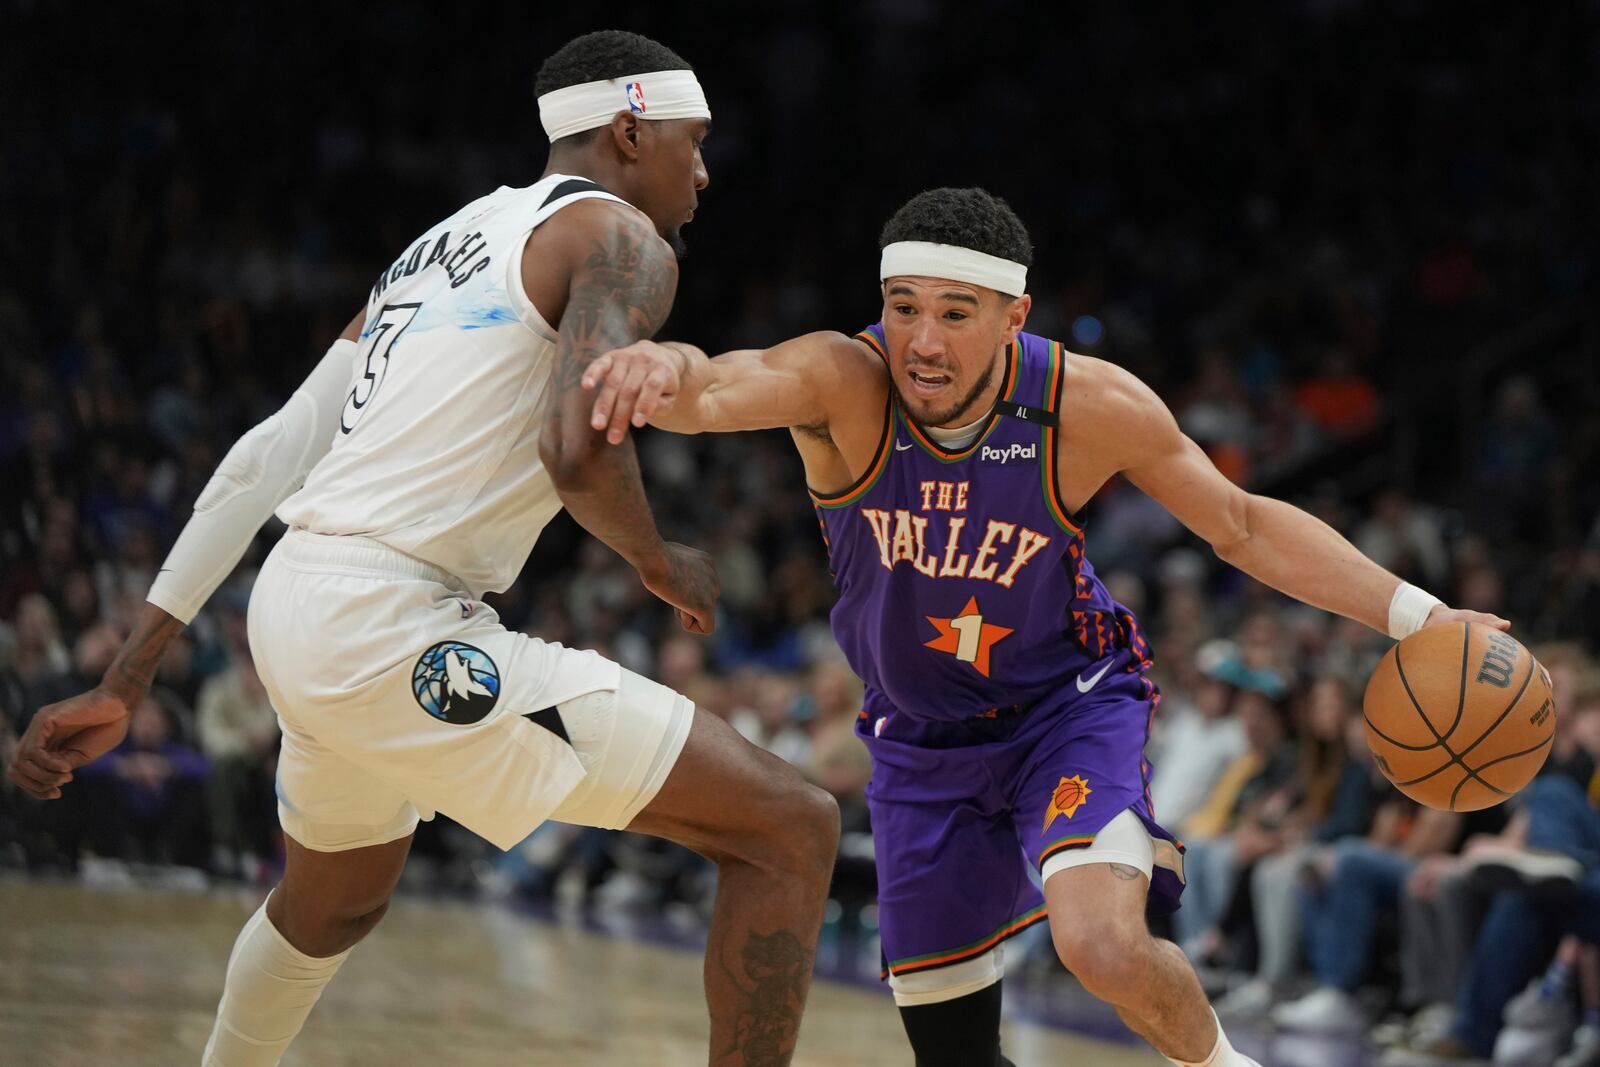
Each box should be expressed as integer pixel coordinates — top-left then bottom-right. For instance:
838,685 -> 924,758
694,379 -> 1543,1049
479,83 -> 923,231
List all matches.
582,331 -> 880,443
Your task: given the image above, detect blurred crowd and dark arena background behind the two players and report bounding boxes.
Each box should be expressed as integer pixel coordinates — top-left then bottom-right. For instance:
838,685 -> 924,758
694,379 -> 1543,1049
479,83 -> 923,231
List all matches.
0,0 -> 1600,1064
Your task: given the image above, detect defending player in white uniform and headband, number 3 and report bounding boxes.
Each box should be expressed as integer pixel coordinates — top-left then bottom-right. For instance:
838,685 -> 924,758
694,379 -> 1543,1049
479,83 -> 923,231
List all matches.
11,32 -> 838,1067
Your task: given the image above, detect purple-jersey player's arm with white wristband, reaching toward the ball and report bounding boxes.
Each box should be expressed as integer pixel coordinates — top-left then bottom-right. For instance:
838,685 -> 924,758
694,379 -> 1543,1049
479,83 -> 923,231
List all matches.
1085,360 -> 1510,637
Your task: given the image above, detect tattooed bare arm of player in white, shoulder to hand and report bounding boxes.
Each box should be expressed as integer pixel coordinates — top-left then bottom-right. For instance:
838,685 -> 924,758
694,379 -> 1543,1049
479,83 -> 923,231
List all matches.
522,202 -> 717,633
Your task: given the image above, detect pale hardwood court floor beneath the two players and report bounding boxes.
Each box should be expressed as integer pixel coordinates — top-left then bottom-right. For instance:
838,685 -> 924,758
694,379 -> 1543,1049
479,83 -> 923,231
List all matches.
0,880 -> 1163,1067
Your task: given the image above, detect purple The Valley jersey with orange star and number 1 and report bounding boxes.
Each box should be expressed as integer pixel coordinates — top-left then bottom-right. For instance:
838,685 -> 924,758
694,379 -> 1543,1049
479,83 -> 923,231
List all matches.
813,323 -> 1149,721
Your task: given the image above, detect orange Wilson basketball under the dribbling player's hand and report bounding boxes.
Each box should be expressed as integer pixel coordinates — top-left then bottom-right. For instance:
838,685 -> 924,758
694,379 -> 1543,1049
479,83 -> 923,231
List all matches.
1363,622 -> 1555,811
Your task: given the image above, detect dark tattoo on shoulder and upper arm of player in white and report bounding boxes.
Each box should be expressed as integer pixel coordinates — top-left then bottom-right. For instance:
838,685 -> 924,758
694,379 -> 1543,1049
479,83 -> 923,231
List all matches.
555,218 -> 678,392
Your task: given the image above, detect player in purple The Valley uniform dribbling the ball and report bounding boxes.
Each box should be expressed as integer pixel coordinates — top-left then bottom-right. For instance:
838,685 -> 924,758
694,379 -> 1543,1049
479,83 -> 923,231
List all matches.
584,189 -> 1507,1067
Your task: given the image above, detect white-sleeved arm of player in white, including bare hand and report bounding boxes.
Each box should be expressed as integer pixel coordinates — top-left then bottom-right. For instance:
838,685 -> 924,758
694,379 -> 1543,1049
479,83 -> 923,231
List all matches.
8,314 -> 365,800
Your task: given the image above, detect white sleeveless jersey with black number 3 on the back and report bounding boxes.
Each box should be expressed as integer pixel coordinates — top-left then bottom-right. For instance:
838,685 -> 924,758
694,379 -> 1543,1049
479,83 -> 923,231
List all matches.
277,174 -> 621,595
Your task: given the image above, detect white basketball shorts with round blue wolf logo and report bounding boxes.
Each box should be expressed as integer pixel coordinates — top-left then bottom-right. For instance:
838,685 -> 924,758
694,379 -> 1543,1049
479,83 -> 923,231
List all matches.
250,530 -> 694,851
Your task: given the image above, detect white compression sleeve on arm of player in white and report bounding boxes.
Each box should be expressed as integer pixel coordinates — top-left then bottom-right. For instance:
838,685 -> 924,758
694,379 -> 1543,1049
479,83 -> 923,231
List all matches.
146,338 -> 357,624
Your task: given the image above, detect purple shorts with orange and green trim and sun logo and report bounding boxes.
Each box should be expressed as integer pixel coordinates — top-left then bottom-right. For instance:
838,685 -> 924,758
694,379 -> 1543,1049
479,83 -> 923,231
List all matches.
856,653 -> 1182,974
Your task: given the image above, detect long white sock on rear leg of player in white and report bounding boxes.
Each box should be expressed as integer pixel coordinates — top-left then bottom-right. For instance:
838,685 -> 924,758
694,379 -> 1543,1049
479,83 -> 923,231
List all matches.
200,902 -> 350,1067
